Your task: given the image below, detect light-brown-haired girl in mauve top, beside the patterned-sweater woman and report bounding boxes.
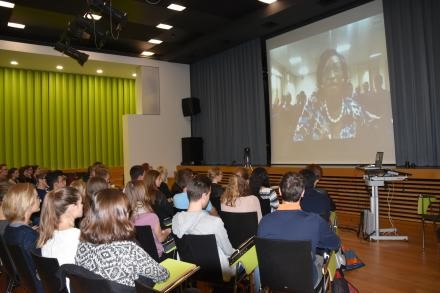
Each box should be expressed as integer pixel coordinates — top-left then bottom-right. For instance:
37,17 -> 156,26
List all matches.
125,180 -> 171,257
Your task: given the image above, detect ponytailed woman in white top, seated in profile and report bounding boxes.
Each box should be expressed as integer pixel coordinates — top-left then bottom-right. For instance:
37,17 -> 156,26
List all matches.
37,187 -> 83,265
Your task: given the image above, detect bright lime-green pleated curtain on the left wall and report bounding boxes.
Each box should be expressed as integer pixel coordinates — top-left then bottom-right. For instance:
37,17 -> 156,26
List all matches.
0,68 -> 136,169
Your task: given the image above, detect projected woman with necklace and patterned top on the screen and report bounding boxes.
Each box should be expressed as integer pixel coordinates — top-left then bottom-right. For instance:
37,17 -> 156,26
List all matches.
293,49 -> 378,141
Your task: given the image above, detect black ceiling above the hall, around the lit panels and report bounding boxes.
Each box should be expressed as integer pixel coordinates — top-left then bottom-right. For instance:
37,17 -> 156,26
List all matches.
0,0 -> 369,63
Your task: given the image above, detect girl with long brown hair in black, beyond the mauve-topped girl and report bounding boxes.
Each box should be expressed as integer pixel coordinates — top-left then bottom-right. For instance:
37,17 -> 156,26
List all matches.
144,170 -> 174,223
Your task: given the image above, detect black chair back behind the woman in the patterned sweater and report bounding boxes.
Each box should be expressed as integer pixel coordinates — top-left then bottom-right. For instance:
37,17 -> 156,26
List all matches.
60,264 -> 136,293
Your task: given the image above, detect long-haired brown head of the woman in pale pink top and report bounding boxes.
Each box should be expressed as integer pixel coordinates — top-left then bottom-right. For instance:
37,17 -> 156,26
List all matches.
220,168 -> 250,206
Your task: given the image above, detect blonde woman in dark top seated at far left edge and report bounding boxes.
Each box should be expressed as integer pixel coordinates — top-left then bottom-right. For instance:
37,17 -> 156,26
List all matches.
2,183 -> 43,292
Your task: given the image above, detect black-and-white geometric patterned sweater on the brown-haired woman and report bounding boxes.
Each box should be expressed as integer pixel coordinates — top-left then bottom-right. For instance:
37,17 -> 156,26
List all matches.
75,241 -> 169,287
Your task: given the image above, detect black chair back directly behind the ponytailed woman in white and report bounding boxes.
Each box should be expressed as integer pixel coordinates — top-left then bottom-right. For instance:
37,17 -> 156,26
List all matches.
31,252 -> 68,293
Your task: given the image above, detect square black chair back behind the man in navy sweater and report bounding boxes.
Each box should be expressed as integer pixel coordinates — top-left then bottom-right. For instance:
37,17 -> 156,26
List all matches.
255,237 -> 313,293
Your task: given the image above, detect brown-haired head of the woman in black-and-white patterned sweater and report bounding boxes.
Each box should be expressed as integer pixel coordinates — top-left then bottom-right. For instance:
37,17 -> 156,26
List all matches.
80,188 -> 135,244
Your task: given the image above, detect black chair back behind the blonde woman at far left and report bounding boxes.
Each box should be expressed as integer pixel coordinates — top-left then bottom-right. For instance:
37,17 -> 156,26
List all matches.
7,245 -> 43,292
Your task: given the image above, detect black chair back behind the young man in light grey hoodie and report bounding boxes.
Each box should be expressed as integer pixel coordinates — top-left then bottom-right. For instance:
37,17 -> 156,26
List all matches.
173,234 -> 223,283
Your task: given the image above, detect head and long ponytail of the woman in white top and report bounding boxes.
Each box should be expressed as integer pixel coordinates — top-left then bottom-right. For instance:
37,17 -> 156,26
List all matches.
37,187 -> 83,247
